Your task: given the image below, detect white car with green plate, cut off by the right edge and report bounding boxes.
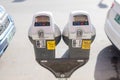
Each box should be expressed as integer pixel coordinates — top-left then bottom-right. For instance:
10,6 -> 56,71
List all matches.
105,0 -> 120,50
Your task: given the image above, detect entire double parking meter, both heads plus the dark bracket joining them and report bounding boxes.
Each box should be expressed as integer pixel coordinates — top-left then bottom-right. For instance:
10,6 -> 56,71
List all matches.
28,11 -> 95,78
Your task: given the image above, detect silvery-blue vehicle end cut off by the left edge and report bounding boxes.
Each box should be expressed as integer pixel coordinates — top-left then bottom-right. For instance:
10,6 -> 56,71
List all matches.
0,5 -> 16,56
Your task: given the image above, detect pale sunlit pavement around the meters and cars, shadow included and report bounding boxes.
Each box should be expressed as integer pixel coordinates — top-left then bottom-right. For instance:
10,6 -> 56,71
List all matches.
0,0 -> 120,80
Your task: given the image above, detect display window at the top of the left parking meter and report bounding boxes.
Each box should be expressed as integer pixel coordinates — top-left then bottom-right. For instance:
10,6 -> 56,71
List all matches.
34,16 -> 50,27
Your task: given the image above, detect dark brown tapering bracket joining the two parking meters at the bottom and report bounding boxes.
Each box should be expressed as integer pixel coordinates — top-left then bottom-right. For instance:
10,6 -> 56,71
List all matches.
38,58 -> 88,79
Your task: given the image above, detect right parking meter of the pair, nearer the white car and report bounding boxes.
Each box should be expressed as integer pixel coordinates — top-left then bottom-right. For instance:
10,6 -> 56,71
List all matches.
62,11 -> 95,59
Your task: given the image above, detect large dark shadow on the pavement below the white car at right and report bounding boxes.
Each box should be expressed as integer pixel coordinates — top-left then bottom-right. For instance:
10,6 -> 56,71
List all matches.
94,46 -> 120,80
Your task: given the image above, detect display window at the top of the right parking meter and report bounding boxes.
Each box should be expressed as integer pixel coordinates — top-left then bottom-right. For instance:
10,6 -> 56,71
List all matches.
73,15 -> 89,26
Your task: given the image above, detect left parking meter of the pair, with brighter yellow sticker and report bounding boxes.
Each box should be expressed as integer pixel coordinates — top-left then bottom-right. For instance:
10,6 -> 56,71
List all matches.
28,12 -> 61,62
